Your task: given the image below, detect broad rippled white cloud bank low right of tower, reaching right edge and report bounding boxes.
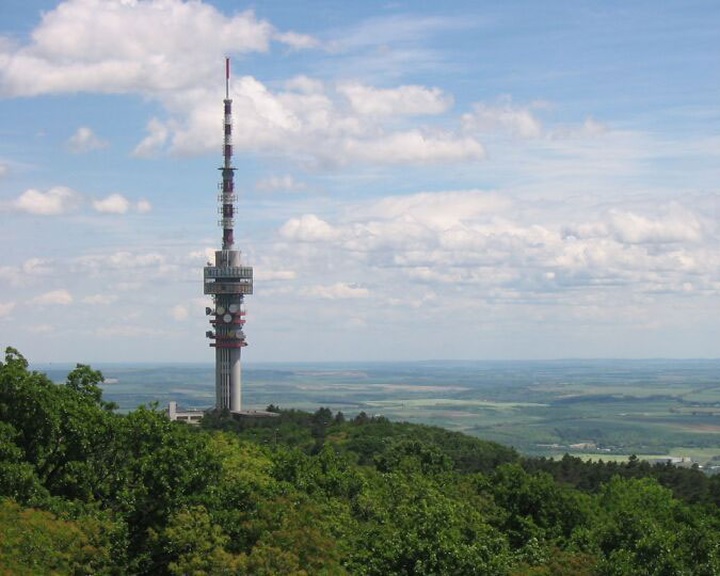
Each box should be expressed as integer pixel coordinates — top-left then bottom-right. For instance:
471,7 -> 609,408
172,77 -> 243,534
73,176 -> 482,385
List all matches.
278,190 -> 720,306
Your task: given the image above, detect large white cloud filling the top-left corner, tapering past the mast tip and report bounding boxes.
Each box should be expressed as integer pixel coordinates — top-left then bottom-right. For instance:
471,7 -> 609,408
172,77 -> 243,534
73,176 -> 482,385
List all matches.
0,0 -> 316,96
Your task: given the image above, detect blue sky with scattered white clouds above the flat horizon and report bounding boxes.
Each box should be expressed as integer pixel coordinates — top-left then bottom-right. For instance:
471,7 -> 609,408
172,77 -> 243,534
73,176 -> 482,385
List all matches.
0,0 -> 720,363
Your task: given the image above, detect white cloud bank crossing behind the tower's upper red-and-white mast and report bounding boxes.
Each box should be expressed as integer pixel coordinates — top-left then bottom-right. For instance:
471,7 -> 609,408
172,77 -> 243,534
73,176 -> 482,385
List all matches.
134,69 -> 485,168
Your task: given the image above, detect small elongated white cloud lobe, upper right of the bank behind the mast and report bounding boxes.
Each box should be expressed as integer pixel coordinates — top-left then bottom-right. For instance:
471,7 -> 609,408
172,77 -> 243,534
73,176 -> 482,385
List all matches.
338,83 -> 453,116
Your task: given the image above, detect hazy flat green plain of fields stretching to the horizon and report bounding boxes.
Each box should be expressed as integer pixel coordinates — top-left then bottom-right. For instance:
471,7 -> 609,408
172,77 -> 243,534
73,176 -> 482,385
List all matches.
38,360 -> 720,465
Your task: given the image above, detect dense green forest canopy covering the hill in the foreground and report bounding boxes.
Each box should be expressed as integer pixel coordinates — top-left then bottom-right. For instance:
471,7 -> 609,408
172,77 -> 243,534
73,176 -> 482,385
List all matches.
0,348 -> 720,576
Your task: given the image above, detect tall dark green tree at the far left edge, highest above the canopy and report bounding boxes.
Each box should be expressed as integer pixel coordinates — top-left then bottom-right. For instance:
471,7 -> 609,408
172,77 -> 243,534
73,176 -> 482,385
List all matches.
0,348 -> 119,501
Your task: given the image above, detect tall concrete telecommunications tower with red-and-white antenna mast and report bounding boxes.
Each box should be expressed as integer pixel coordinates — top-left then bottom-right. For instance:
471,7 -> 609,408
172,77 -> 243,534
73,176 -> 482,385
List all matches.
203,58 -> 253,412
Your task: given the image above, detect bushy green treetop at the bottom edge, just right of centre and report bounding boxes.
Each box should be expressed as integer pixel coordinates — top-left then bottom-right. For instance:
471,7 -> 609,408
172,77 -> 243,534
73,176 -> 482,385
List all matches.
346,473 -> 510,576
